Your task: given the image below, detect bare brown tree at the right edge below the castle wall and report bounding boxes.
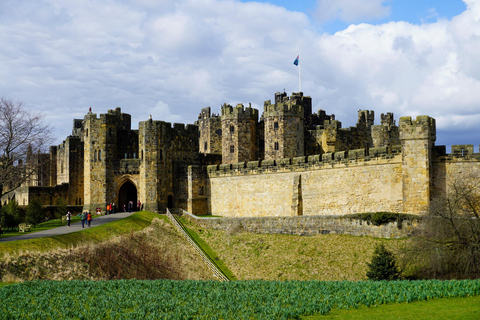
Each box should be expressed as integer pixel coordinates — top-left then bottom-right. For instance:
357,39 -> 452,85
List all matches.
407,174 -> 480,279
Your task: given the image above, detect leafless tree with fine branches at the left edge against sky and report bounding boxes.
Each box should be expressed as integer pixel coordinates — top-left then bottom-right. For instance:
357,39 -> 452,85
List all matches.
0,98 -> 52,196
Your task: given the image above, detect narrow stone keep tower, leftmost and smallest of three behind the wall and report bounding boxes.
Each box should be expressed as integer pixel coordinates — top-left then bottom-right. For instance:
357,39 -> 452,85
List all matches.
196,107 -> 222,154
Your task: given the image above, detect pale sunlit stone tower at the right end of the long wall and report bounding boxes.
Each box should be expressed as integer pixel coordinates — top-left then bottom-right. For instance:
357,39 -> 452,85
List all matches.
399,116 -> 436,214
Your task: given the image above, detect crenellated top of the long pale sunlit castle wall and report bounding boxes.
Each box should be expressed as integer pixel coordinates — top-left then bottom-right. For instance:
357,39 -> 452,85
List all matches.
207,148 -> 402,177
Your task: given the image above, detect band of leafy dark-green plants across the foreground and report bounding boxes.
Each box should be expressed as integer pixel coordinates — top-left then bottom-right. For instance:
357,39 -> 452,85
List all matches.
0,280 -> 480,319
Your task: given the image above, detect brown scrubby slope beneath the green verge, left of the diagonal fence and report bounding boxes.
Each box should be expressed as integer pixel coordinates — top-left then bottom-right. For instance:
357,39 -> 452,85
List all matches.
0,216 -> 213,282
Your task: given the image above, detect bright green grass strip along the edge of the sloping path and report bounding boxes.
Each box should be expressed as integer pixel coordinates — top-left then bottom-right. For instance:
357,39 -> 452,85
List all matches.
0,211 -> 161,259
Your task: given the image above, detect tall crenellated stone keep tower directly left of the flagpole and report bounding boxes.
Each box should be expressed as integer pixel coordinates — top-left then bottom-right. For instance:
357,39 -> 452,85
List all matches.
263,92 -> 304,160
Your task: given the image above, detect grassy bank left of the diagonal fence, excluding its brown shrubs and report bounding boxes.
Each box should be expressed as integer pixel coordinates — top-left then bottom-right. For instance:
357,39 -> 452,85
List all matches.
0,212 -> 214,282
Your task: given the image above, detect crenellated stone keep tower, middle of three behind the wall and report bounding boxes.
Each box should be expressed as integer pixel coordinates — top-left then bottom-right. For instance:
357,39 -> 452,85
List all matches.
222,104 -> 258,163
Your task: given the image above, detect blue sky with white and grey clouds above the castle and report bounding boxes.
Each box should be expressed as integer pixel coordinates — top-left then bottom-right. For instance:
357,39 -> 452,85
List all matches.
0,0 -> 480,151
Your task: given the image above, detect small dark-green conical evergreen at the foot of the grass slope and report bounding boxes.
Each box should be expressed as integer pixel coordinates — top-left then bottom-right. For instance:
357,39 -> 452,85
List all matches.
367,243 -> 400,280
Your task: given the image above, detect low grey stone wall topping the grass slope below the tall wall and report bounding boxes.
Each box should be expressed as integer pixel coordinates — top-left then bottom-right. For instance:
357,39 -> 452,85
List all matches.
183,211 -> 418,238
